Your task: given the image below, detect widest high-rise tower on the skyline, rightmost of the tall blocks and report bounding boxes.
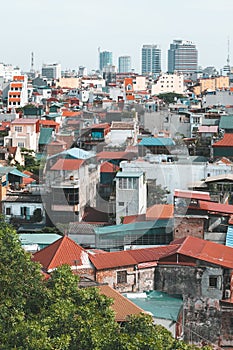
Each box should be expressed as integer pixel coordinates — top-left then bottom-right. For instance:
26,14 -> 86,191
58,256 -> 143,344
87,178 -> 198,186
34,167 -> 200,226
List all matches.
168,40 -> 198,77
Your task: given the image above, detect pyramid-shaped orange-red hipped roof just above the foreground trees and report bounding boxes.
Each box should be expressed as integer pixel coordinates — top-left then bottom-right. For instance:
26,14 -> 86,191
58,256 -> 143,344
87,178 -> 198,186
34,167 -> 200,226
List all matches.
33,236 -> 87,271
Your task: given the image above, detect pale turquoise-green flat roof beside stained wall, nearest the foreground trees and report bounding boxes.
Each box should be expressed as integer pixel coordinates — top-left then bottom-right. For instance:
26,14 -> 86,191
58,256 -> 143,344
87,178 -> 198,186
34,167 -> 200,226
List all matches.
125,290 -> 183,321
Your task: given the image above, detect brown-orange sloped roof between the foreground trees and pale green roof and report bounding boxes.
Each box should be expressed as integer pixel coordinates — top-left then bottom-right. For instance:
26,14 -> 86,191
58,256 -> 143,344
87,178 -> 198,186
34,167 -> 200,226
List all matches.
97,285 -> 144,322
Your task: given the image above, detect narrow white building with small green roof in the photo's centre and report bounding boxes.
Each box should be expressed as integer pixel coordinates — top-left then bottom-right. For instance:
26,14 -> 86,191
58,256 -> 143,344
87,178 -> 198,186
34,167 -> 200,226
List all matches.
116,171 -> 147,224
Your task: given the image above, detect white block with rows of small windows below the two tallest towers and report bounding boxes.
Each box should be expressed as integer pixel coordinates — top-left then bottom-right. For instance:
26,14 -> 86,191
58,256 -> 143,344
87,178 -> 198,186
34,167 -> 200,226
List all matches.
151,73 -> 184,95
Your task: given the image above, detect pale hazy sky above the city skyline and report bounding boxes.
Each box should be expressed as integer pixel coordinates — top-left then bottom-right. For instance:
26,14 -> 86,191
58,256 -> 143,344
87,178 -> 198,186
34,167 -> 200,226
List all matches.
0,0 -> 233,72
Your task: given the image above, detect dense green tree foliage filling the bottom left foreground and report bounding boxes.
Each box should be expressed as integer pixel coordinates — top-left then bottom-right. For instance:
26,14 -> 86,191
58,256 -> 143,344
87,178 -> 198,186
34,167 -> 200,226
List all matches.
0,218 -> 213,350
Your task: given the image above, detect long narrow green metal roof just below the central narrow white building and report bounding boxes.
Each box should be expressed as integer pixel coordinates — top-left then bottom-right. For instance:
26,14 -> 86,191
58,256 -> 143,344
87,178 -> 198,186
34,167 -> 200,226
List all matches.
94,219 -> 173,237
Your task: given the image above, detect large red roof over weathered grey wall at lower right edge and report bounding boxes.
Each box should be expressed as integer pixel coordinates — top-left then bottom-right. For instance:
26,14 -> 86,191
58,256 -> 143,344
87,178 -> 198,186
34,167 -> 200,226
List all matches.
163,236 -> 233,269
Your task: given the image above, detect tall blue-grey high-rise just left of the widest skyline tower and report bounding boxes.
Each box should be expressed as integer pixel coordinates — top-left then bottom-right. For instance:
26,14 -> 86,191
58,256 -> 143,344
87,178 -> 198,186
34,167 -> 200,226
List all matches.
142,45 -> 161,76
